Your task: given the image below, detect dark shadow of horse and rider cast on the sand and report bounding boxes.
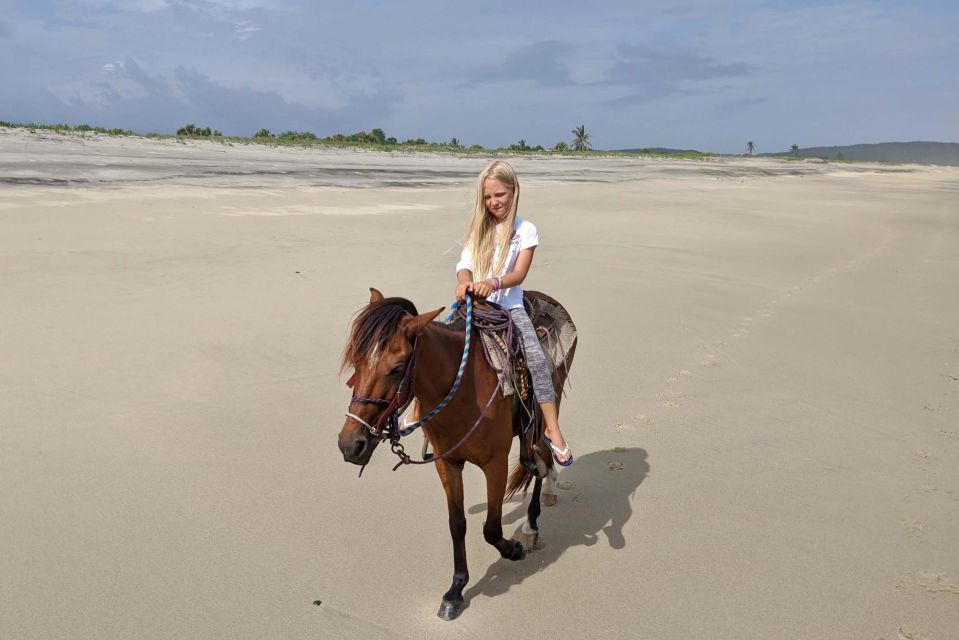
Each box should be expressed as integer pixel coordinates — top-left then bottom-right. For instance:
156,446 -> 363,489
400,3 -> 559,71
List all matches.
463,447 -> 649,606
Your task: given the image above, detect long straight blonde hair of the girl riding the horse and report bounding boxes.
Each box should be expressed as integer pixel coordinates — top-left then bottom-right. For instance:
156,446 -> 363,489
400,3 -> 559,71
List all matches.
463,160 -> 519,279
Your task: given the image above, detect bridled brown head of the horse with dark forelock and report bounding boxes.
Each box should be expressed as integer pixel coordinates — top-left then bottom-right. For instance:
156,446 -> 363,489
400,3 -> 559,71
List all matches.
338,288 -> 442,466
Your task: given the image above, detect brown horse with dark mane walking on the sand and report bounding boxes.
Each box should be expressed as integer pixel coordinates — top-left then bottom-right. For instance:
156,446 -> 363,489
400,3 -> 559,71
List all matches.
339,289 -> 576,620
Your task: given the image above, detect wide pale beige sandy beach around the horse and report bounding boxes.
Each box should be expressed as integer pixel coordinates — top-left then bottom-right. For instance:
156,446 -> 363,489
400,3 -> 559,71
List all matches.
0,130 -> 959,640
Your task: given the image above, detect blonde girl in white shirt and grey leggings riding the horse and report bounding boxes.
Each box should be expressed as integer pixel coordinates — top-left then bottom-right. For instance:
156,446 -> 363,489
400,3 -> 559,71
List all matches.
456,162 -> 573,467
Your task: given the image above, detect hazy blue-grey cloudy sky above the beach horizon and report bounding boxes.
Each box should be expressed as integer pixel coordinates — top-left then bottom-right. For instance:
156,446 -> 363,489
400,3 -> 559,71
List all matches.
0,0 -> 959,153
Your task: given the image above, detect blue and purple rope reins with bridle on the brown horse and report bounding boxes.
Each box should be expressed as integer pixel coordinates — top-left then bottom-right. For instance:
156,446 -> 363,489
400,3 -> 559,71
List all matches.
346,295 -> 501,473
